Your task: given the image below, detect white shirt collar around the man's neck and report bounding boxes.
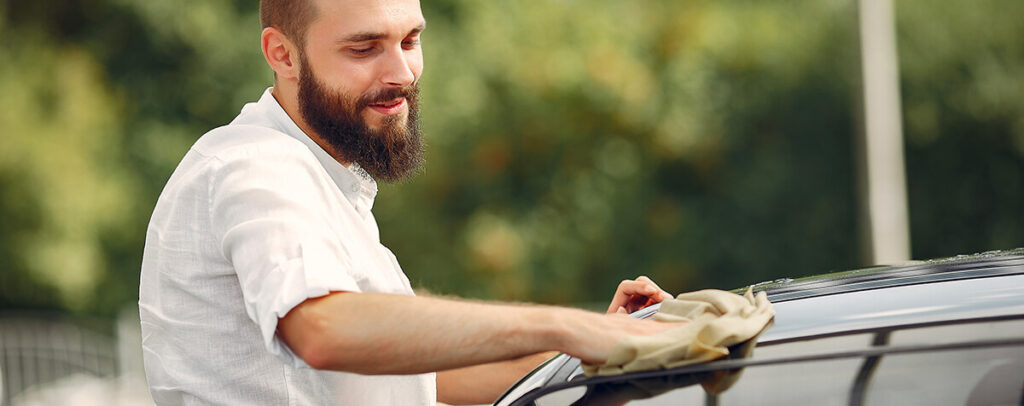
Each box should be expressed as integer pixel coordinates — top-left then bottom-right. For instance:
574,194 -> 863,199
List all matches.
242,87 -> 377,215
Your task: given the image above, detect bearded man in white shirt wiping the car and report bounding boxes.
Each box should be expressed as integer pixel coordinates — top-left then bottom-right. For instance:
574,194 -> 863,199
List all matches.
139,0 -> 671,405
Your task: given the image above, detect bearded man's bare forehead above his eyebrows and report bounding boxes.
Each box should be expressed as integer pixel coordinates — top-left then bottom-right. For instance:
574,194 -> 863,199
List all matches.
309,0 -> 424,39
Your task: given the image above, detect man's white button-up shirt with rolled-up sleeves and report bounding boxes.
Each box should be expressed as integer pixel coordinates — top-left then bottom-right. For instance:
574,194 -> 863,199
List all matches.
138,89 -> 436,405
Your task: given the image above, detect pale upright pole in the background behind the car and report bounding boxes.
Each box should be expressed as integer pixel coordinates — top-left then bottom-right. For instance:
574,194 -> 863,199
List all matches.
859,0 -> 910,263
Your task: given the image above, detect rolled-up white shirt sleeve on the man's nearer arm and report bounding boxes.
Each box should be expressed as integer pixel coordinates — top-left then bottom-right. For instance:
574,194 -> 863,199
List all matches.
209,138 -> 359,367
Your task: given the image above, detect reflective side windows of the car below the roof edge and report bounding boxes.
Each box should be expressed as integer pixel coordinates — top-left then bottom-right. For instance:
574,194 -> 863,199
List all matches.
512,318 -> 1024,406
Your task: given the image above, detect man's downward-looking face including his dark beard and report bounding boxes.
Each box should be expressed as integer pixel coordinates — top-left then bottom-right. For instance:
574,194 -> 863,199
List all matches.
298,0 -> 424,181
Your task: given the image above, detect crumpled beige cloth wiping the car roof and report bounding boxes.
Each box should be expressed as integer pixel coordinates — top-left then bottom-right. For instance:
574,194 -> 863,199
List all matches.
583,289 -> 774,376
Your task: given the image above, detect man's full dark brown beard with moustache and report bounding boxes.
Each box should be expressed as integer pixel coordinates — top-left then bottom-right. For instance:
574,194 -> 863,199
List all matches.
298,55 -> 424,182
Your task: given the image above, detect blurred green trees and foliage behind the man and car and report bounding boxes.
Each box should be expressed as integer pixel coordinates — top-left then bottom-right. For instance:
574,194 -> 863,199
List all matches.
0,0 -> 1024,405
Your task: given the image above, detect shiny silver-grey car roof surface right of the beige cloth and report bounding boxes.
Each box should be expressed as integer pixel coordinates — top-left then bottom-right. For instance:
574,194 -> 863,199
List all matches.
633,249 -> 1024,342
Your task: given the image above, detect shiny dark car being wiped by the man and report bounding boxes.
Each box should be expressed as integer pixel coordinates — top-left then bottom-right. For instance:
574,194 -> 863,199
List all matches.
496,249 -> 1024,406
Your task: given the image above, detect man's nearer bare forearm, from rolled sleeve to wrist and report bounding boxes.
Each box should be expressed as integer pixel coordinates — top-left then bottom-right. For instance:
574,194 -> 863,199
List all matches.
279,293 -> 585,374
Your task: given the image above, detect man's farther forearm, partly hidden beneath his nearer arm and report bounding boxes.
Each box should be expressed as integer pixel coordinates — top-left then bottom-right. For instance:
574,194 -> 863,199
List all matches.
437,352 -> 558,405
